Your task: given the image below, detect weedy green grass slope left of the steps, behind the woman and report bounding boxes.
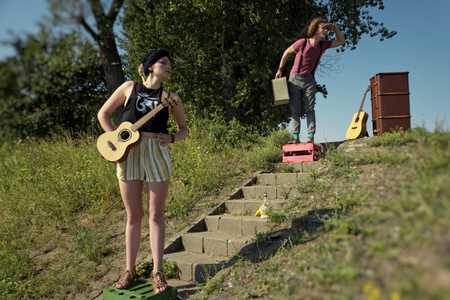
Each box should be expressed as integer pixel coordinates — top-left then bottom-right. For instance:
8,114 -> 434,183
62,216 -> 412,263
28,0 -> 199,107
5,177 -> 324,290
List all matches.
0,120 -> 286,299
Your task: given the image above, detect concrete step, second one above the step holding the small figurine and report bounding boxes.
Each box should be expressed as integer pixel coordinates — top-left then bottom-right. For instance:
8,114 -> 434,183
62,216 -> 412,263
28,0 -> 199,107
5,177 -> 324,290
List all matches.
242,185 -> 300,200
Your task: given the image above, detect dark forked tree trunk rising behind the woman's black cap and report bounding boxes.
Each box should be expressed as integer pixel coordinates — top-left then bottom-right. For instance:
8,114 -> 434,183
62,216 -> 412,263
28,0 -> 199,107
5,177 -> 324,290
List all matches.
48,0 -> 125,94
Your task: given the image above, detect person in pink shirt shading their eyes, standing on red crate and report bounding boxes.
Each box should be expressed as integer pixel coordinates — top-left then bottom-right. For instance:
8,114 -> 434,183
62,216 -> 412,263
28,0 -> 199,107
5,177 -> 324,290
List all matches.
275,18 -> 345,143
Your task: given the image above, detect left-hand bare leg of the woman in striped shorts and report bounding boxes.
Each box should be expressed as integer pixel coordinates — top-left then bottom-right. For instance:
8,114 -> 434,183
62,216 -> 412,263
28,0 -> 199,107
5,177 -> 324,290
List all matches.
119,180 -> 143,271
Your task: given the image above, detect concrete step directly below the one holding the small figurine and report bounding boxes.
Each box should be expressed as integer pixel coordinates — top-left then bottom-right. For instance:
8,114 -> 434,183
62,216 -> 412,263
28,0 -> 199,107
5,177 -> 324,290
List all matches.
182,231 -> 254,257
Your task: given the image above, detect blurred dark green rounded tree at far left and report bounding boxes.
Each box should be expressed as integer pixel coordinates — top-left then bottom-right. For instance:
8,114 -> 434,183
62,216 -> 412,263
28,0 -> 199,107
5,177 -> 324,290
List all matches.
0,27 -> 107,139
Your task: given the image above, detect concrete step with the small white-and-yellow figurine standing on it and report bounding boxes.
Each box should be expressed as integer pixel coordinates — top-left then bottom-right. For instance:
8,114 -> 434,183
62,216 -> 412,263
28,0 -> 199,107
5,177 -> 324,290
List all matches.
205,215 -> 273,236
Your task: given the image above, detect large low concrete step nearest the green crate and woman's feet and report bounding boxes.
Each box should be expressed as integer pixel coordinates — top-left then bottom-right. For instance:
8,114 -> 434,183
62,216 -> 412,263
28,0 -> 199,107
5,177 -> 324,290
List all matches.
164,251 -> 228,282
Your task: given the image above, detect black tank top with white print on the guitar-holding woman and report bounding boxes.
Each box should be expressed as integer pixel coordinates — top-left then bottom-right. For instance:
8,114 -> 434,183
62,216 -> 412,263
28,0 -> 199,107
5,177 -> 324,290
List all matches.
120,82 -> 169,133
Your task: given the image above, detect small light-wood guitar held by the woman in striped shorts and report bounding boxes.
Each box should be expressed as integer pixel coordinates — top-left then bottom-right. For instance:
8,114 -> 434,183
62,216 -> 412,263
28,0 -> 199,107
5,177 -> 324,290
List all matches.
97,94 -> 176,162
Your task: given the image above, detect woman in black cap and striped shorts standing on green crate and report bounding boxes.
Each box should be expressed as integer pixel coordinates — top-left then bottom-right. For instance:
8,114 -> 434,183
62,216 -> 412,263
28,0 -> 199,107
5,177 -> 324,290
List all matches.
98,49 -> 188,293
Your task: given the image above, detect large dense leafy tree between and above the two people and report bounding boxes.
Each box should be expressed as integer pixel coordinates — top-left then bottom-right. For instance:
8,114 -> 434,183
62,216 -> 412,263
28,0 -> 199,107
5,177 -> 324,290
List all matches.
122,0 -> 395,125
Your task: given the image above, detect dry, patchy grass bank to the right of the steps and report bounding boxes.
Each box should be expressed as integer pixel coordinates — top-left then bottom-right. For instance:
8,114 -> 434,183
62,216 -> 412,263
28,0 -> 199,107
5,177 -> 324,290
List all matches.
194,129 -> 450,300
